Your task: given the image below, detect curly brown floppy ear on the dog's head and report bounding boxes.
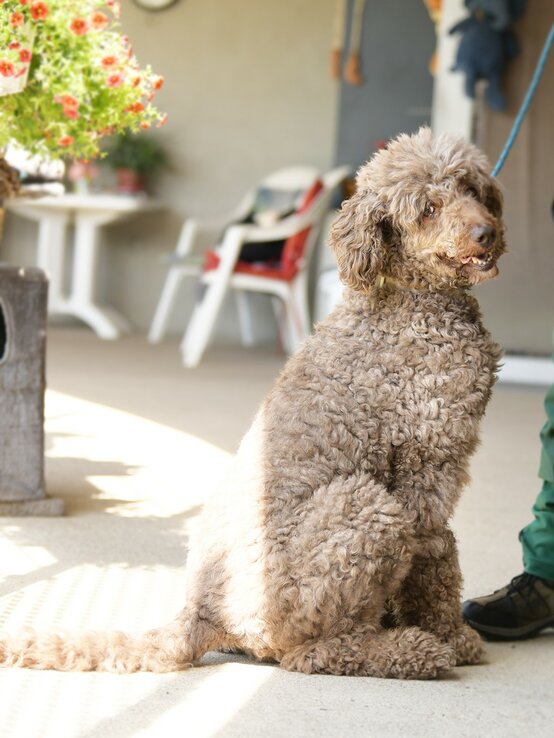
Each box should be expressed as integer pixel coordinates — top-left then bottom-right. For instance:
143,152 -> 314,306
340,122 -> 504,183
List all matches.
330,189 -> 386,292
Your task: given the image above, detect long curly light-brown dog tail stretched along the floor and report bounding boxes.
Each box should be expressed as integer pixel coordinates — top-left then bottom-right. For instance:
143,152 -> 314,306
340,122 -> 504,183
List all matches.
0,617 -> 217,673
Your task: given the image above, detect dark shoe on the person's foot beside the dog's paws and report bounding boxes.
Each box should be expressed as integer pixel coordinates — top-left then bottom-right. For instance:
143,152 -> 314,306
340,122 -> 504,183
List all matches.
462,573 -> 554,641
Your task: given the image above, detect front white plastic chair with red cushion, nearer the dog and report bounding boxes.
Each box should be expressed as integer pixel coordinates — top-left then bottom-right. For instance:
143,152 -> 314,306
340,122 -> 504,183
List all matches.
181,167 -> 351,367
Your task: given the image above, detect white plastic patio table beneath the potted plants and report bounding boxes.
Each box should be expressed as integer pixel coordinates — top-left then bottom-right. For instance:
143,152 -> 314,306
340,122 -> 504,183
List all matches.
6,194 -> 159,339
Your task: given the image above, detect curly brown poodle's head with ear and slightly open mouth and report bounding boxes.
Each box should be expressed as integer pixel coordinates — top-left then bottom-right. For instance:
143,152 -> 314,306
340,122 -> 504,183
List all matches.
331,128 -> 505,292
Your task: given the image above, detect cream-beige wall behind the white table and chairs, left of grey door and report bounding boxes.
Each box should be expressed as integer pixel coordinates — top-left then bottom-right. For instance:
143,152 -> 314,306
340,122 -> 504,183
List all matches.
2,0 -> 337,333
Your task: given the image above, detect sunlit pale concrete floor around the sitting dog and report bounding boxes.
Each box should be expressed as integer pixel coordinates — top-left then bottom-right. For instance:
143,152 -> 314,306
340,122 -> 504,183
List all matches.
0,329 -> 554,738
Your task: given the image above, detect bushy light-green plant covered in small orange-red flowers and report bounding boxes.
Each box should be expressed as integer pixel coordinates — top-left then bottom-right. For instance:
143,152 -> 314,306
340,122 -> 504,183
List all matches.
0,0 -> 165,159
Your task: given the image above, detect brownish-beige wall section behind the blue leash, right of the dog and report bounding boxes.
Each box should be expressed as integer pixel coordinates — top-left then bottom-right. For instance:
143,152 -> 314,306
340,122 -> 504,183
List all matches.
477,0 -> 554,354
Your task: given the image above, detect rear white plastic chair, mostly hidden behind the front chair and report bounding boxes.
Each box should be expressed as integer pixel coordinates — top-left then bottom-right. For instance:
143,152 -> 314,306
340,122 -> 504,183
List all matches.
148,166 -> 319,343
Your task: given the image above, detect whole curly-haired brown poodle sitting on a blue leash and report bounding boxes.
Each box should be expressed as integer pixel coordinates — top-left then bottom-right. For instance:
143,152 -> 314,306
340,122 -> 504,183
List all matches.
0,129 -> 504,678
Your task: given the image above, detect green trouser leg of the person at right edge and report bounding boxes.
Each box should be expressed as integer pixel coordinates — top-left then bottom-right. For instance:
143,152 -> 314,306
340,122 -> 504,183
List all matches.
519,384 -> 554,580
